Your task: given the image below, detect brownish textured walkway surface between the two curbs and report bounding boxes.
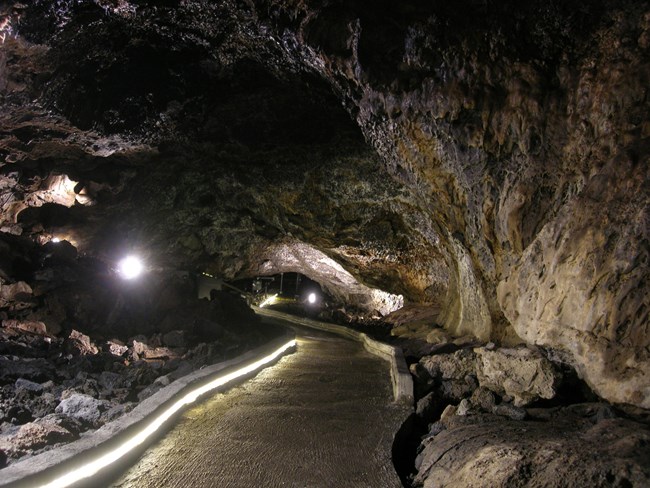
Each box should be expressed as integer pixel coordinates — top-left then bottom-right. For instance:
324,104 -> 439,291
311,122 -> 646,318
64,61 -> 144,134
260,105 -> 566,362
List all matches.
112,324 -> 407,488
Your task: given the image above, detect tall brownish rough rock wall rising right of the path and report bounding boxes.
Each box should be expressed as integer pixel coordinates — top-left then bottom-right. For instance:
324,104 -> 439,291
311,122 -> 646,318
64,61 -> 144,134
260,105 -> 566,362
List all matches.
249,1 -> 650,407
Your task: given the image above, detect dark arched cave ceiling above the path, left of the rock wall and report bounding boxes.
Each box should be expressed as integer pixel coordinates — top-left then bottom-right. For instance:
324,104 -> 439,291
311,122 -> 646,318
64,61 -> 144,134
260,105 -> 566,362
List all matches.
2,2 -> 444,304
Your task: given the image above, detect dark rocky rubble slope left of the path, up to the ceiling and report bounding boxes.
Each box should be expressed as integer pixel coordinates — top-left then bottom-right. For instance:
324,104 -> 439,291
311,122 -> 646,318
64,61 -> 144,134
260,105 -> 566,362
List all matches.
0,236 -> 275,464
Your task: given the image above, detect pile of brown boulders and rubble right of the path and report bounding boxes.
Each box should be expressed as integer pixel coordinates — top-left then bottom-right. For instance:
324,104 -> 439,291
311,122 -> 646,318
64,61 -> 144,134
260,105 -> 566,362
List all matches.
408,344 -> 650,488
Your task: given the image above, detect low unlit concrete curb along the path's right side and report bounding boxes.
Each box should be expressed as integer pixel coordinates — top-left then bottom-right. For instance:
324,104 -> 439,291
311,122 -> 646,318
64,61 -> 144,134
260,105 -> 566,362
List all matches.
252,307 -> 414,406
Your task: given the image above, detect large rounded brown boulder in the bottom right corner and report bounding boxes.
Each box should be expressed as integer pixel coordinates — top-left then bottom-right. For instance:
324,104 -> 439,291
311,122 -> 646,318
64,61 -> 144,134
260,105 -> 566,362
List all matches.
413,411 -> 650,488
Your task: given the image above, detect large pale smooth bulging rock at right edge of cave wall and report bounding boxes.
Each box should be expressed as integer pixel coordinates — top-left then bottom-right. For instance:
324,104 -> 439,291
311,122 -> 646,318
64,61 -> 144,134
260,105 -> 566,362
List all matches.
497,169 -> 650,408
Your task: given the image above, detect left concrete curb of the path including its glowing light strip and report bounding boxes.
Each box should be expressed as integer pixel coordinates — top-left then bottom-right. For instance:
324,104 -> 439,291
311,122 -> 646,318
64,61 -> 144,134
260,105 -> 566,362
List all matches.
0,337 -> 296,488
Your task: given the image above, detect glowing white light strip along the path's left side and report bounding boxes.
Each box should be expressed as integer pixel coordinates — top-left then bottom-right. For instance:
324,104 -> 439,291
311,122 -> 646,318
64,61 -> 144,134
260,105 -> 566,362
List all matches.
41,339 -> 296,488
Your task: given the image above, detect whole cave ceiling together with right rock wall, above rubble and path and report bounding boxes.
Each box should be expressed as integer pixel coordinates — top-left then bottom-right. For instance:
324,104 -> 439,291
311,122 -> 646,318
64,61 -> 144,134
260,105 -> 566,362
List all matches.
0,0 -> 650,407
